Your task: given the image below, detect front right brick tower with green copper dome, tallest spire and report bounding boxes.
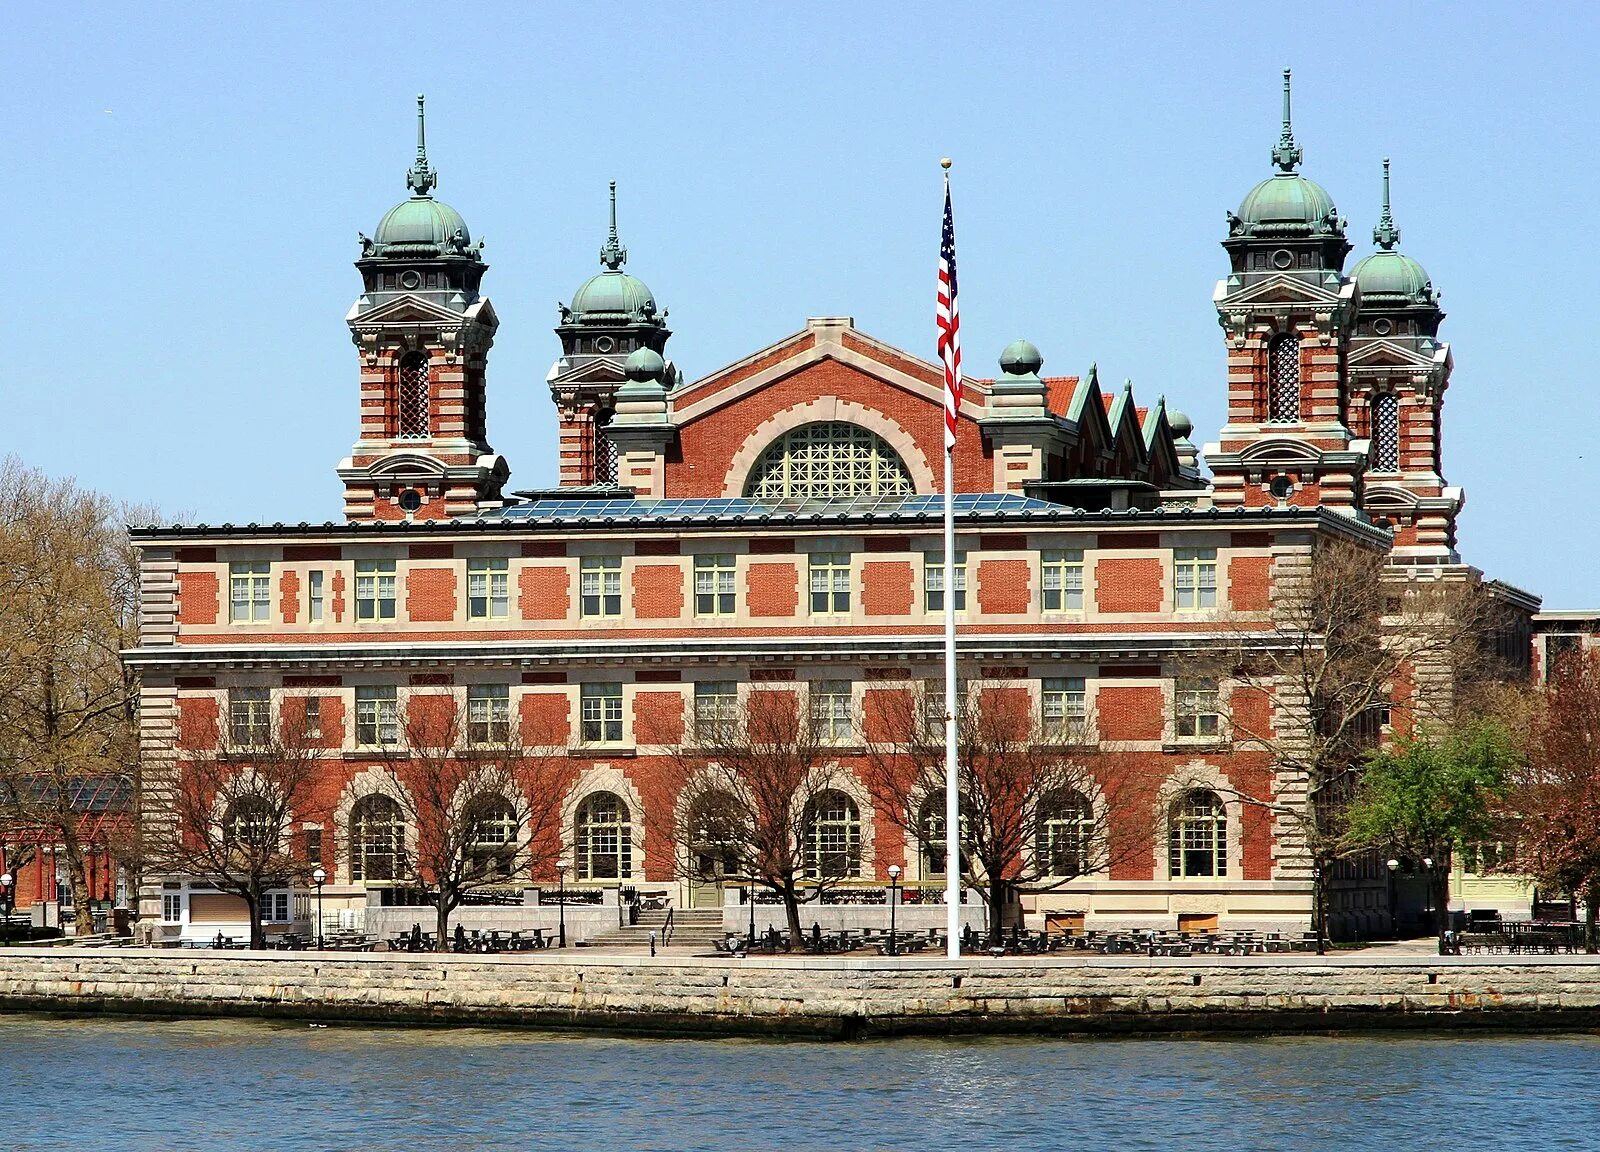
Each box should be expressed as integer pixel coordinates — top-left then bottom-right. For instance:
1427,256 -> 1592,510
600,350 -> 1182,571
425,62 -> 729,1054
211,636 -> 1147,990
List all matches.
1205,69 -> 1362,514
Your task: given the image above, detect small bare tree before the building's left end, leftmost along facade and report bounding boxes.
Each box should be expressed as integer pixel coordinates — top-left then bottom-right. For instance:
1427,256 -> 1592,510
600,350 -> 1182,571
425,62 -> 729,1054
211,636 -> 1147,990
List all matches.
161,710 -> 323,949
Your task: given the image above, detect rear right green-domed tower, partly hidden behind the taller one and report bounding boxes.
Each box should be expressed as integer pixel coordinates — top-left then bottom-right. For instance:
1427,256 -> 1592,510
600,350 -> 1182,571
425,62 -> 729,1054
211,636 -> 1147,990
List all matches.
1347,158 -> 1466,563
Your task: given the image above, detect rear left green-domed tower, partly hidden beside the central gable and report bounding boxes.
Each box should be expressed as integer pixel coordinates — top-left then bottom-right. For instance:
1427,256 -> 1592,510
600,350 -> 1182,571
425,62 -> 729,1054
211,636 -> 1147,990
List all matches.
547,181 -> 677,488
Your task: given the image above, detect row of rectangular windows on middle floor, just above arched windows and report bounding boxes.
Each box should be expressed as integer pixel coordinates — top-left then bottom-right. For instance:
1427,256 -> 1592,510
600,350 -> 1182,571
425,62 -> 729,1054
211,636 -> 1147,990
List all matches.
229,677 -> 1222,749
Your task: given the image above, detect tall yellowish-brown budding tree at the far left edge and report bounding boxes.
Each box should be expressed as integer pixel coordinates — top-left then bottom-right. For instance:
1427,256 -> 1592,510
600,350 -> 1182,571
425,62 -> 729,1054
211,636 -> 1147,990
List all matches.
0,458 -> 147,928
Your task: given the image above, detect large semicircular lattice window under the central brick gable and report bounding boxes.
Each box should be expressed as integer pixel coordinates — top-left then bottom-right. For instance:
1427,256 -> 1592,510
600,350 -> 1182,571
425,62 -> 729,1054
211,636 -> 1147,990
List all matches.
744,421 -> 917,504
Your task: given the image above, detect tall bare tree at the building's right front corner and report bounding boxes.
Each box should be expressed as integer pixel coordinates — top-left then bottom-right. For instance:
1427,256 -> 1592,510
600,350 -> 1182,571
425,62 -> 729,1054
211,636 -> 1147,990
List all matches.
1179,536 -> 1509,934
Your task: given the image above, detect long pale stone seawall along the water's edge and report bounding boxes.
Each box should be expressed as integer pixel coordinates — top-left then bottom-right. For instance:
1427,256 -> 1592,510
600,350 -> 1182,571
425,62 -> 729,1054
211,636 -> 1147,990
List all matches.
0,949 -> 1600,1037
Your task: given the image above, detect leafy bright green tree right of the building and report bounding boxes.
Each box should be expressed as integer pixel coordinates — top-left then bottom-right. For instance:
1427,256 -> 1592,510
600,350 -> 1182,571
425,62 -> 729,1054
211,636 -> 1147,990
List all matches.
1346,720 -> 1522,941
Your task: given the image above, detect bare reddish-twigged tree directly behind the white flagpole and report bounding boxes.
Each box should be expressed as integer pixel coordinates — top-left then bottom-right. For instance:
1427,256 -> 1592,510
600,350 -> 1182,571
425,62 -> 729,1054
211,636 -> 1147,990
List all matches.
862,685 -> 1157,939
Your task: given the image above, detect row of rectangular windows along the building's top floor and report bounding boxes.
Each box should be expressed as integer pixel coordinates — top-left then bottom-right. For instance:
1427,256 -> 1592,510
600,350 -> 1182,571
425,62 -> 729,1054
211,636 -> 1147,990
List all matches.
229,549 -> 1216,624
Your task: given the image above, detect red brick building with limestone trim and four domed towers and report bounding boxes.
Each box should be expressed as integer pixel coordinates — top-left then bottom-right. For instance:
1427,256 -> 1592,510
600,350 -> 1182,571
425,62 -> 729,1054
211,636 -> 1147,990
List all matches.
128,90 -> 1536,936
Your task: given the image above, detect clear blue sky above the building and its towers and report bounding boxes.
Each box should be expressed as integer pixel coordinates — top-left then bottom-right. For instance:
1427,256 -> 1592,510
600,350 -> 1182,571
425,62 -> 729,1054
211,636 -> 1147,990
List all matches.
0,0 -> 1600,608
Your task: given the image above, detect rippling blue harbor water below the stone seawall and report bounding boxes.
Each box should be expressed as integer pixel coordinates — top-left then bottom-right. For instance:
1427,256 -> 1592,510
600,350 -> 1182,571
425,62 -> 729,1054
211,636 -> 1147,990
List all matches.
0,1016 -> 1600,1152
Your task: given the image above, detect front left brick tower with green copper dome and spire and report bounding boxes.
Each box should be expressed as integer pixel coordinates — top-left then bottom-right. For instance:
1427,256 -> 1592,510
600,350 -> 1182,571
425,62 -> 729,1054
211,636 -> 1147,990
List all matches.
339,96 -> 510,520
